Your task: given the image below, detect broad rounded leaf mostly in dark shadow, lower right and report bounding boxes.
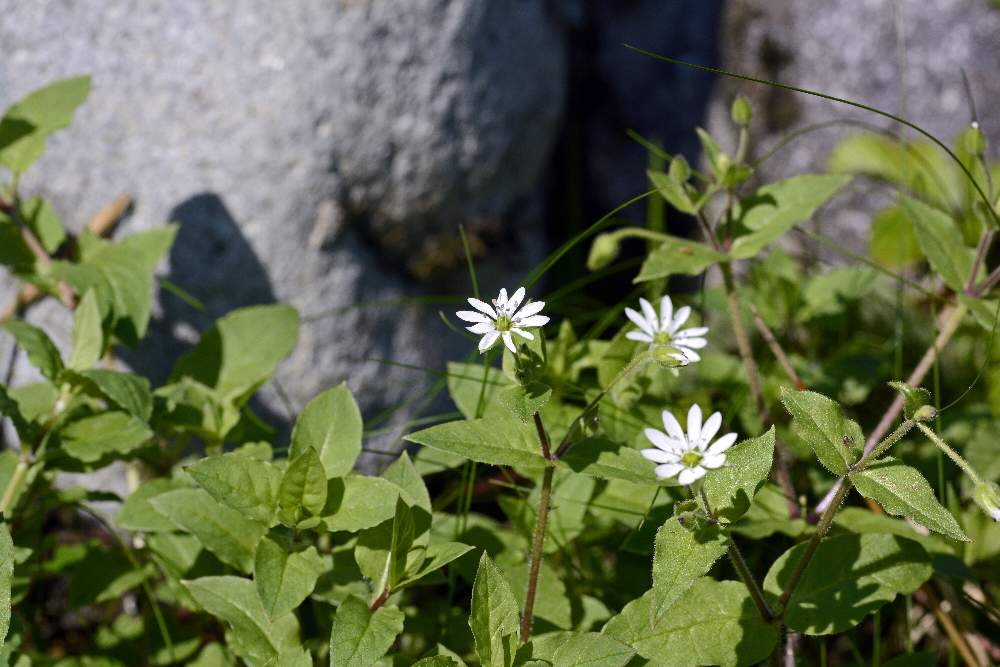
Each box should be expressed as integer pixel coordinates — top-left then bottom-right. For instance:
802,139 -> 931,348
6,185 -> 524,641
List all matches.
764,534 -> 933,635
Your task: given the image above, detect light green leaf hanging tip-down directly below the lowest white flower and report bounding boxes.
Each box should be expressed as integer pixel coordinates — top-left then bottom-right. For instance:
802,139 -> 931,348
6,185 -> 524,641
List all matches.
649,517 -> 729,625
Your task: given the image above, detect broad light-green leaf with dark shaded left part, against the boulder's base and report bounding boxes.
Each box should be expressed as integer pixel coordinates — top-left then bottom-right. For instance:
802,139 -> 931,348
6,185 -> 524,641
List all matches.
172,305 -> 299,402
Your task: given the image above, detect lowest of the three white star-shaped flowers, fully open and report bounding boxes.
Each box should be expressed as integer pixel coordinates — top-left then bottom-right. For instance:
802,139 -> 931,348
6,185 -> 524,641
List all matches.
642,405 -> 736,485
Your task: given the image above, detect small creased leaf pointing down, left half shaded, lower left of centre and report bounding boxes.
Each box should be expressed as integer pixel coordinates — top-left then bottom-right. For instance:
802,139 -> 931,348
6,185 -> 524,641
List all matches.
253,537 -> 324,619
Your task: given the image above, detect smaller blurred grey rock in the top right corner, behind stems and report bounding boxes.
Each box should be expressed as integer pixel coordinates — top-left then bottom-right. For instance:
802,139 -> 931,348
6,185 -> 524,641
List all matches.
710,0 -> 1000,250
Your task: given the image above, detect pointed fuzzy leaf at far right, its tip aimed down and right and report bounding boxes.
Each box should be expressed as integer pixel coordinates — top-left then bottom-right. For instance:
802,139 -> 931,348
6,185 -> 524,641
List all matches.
851,456 -> 969,542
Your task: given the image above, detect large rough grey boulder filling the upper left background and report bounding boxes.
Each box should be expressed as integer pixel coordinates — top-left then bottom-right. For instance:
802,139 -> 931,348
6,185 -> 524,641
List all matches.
0,0 -> 565,464
